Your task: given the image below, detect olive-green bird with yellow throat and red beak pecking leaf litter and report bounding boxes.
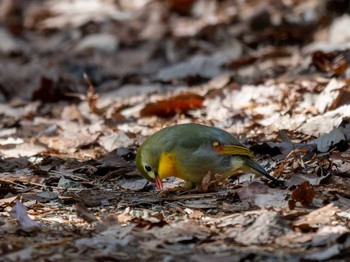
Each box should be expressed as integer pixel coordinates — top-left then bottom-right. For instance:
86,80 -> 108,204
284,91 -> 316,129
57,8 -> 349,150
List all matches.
136,123 -> 284,190
